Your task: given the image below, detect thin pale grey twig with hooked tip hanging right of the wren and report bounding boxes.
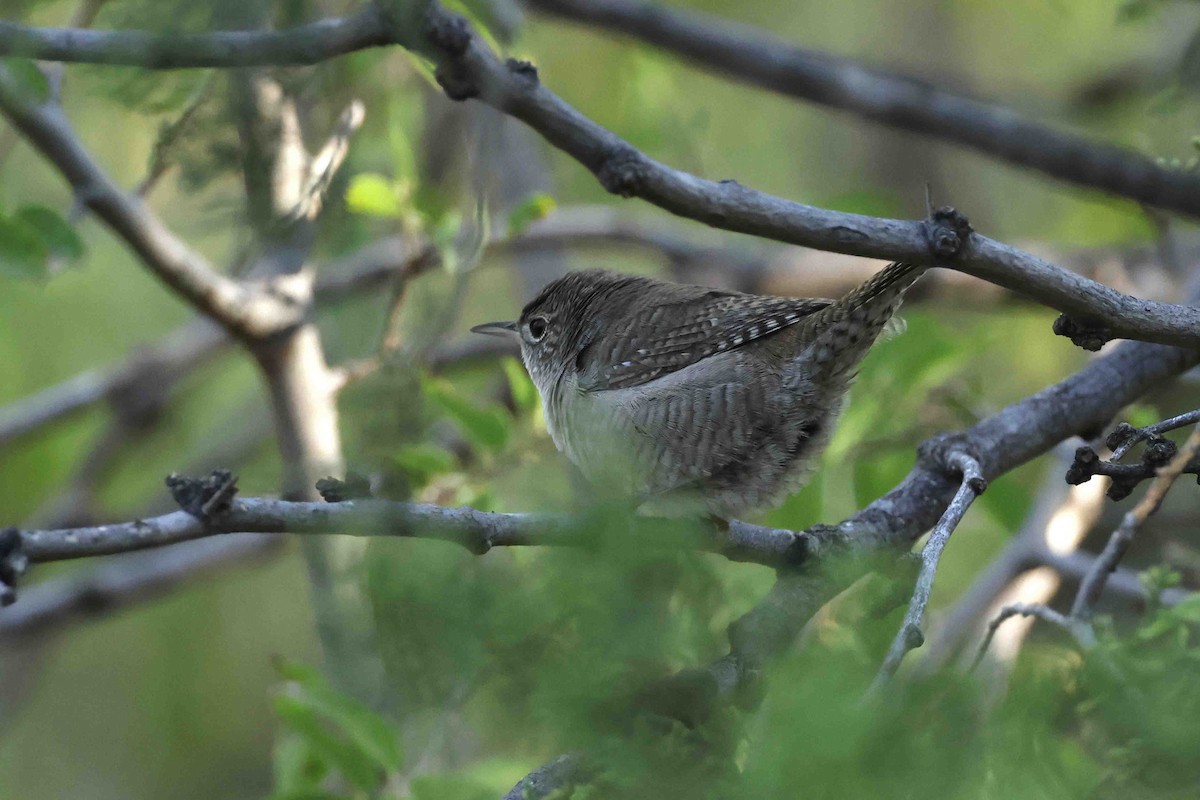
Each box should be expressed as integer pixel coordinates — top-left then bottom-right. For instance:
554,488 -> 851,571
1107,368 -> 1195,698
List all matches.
872,451 -> 988,690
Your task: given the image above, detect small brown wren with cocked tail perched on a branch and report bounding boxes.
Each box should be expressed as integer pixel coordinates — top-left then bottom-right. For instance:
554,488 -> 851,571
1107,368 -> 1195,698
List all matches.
472,264 -> 925,519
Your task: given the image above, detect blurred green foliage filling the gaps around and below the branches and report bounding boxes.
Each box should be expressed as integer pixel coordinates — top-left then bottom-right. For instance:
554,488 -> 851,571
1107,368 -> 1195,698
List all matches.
0,0 -> 1200,800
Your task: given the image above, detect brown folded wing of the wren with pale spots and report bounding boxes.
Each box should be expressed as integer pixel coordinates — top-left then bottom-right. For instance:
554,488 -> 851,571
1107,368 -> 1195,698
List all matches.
576,290 -> 833,392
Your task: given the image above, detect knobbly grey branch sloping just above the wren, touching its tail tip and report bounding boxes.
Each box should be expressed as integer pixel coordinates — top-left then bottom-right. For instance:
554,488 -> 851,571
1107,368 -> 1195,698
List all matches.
427,4 -> 1200,345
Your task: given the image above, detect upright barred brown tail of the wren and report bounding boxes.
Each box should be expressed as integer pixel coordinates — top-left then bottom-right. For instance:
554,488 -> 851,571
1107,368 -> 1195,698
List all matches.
803,263 -> 928,380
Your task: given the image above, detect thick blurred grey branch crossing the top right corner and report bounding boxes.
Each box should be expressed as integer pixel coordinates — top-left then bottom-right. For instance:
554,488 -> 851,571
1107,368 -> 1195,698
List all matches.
527,0 -> 1200,217
